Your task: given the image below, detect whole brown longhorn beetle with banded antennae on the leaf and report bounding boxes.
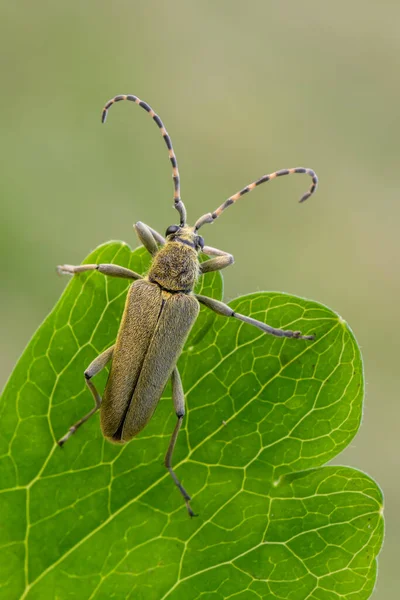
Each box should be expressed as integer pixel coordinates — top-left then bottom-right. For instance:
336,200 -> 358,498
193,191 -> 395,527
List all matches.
58,95 -> 318,517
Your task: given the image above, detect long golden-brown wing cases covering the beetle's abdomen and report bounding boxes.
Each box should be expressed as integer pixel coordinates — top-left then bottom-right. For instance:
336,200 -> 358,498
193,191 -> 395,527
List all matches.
100,279 -> 199,443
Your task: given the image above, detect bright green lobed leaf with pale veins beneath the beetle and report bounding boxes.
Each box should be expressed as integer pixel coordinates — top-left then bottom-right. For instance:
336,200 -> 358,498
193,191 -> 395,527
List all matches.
0,242 -> 383,600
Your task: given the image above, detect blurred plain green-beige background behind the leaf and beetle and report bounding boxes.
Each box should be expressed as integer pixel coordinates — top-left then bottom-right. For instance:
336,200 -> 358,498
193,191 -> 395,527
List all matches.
0,0 -> 400,600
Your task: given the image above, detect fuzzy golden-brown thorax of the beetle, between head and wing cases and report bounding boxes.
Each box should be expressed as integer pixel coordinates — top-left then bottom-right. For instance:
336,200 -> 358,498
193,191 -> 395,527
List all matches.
148,238 -> 200,293
